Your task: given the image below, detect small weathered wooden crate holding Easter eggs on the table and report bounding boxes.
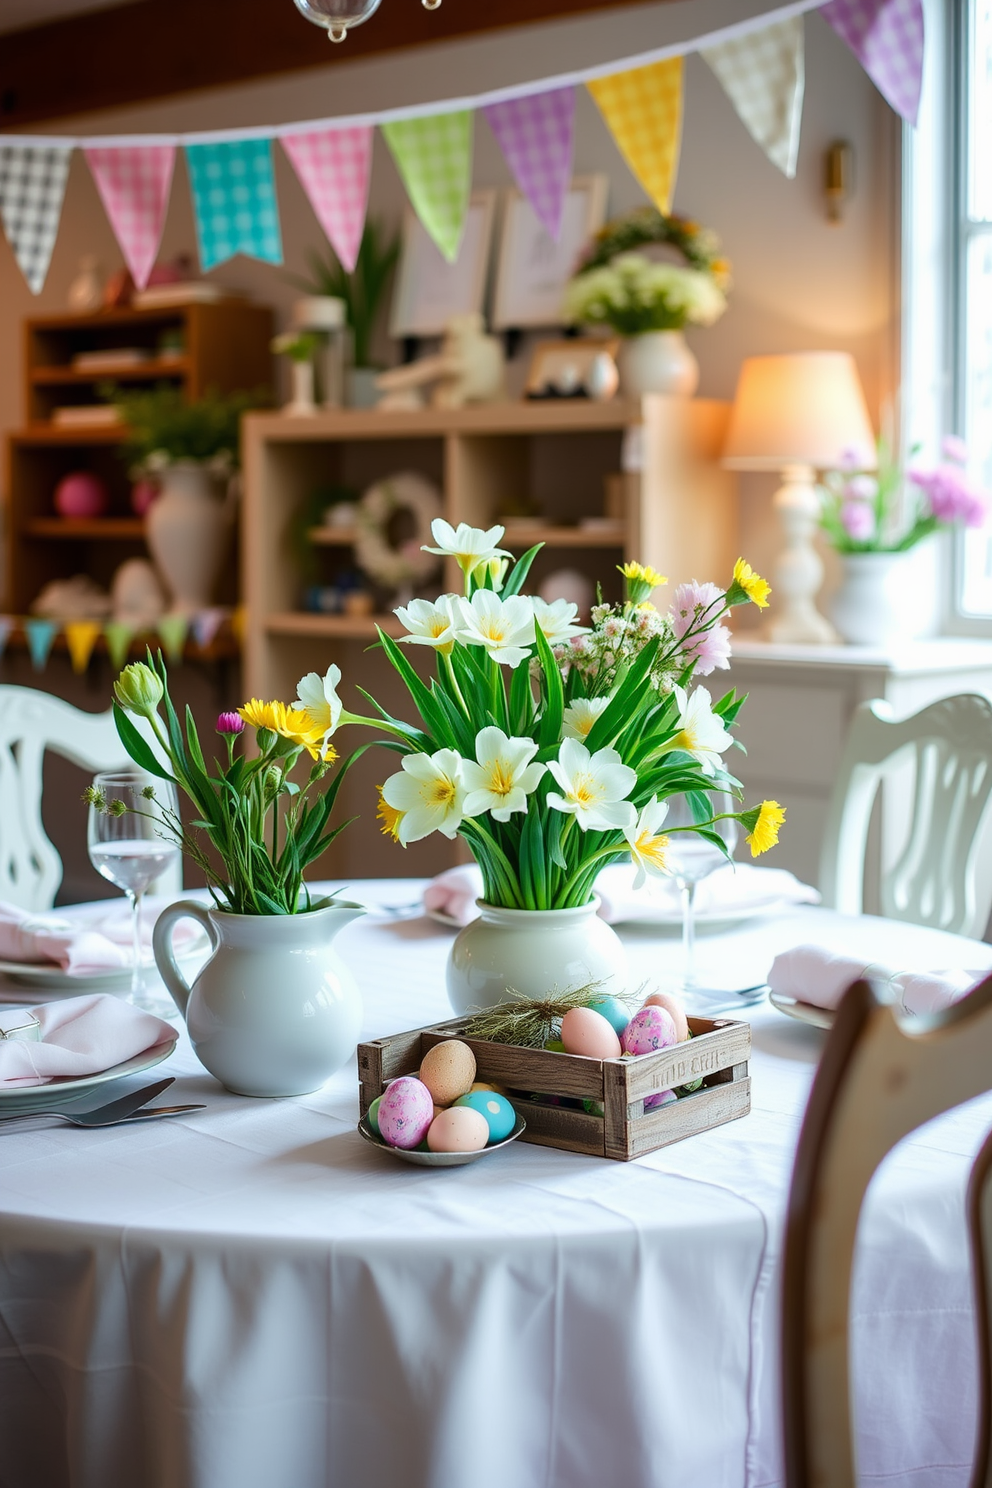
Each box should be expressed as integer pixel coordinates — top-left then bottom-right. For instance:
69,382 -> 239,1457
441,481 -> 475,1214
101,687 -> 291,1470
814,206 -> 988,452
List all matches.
358,1018 -> 751,1162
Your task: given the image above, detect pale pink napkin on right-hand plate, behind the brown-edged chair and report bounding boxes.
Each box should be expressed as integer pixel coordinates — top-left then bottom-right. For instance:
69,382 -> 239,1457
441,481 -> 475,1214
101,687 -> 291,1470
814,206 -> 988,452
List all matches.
767,945 -> 989,1013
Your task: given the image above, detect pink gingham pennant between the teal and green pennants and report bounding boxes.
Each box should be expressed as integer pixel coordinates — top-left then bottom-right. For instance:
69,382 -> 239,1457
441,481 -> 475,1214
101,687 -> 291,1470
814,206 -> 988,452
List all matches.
283,125 -> 372,274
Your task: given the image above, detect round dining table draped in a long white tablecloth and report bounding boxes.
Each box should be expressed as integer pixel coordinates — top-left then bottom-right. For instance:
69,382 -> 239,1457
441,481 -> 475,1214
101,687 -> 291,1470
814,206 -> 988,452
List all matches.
0,879 -> 992,1488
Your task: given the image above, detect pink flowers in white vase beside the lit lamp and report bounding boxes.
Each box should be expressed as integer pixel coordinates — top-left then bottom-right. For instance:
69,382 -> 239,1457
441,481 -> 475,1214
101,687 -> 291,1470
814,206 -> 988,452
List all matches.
821,437 -> 989,554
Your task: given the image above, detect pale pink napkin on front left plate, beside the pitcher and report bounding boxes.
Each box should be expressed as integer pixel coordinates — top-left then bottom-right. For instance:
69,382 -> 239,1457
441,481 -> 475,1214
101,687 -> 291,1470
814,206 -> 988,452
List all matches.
0,992 -> 175,1089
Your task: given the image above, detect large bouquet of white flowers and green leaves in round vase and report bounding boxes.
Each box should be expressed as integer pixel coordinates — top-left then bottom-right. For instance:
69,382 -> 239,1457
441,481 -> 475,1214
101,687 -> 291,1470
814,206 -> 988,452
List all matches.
361,521 -> 784,909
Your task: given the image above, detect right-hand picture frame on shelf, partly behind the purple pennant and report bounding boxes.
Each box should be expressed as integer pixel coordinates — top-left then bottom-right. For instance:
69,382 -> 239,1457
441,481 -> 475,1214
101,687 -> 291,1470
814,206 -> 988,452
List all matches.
492,176 -> 610,330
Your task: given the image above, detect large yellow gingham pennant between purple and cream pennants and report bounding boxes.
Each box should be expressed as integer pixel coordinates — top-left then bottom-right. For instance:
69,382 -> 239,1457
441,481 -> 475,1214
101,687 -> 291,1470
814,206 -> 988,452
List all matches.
586,57 -> 683,213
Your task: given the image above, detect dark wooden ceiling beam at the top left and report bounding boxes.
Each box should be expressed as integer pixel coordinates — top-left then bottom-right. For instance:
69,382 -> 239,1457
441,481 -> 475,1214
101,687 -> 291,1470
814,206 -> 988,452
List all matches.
0,0 -> 666,129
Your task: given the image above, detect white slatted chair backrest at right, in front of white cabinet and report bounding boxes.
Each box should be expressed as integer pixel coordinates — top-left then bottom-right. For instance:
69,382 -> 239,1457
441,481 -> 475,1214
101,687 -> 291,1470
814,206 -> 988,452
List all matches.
819,693 -> 992,939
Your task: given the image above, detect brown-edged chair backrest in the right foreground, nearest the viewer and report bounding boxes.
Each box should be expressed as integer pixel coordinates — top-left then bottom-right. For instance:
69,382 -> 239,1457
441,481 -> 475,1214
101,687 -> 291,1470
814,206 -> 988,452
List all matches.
782,976 -> 992,1488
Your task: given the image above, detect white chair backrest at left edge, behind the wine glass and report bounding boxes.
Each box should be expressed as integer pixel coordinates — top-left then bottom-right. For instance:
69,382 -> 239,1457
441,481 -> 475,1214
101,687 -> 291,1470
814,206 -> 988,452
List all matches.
0,686 -> 181,912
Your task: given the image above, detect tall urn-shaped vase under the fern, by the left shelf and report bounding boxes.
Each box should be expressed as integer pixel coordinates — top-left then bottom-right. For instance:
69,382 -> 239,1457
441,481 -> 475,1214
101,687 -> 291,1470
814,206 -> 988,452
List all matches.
144,460 -> 231,615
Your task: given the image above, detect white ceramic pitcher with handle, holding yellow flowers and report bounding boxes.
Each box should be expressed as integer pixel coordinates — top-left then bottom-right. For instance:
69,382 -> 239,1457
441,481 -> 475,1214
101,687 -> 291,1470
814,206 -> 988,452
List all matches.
152,899 -> 364,1097
